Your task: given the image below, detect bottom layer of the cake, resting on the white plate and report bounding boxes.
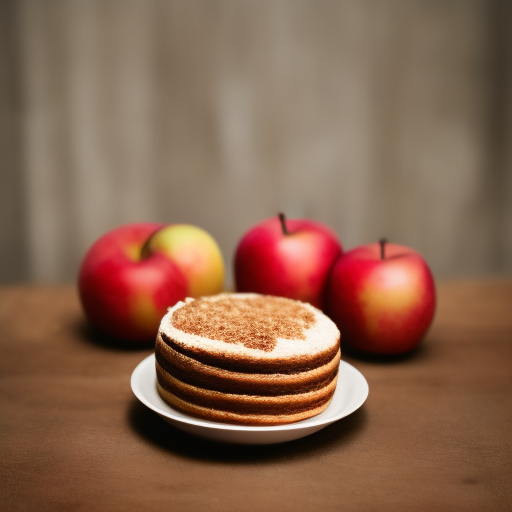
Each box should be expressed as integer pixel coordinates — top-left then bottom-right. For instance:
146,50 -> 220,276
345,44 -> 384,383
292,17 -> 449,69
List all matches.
157,382 -> 336,426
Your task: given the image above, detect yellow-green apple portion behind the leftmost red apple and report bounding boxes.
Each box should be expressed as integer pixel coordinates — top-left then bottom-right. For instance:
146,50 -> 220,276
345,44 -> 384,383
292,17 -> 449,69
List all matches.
144,224 -> 225,297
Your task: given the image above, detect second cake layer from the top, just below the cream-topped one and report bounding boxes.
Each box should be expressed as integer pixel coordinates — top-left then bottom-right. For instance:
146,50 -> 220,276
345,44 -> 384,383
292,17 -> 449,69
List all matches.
155,336 -> 340,396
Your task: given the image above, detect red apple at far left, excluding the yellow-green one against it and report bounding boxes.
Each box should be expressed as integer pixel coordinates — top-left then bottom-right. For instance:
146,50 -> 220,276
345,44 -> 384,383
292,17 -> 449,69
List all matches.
78,223 -> 188,342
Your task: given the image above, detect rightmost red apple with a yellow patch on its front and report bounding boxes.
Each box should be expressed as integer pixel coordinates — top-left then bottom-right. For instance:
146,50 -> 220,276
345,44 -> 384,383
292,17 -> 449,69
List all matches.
327,243 -> 436,355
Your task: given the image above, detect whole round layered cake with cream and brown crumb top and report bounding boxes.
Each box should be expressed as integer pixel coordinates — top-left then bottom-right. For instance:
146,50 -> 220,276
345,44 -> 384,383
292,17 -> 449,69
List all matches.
155,294 -> 340,425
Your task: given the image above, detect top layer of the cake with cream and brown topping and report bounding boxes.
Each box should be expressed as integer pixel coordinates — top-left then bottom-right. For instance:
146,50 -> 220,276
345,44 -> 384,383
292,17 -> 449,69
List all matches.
159,294 -> 340,373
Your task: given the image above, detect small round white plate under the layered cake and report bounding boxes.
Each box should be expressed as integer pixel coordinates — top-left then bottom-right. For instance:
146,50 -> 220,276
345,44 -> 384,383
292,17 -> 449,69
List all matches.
131,354 -> 368,444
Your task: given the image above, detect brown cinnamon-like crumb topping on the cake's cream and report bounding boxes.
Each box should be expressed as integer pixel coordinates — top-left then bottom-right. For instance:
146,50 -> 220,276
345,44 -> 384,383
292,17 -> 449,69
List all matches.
172,295 -> 316,352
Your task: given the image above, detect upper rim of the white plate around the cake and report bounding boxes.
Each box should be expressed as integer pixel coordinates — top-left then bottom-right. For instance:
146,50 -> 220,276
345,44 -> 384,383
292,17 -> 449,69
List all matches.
130,353 -> 369,432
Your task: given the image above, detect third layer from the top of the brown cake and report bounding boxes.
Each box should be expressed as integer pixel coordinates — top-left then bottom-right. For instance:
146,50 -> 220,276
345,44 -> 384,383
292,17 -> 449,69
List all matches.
157,364 -> 337,415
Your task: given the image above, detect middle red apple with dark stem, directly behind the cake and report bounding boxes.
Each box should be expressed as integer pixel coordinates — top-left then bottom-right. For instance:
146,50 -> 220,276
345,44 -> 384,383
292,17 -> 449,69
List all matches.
235,213 -> 342,308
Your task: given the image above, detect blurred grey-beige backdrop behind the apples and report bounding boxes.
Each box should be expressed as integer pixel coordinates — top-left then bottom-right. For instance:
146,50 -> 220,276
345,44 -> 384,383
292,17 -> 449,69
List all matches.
0,0 -> 512,285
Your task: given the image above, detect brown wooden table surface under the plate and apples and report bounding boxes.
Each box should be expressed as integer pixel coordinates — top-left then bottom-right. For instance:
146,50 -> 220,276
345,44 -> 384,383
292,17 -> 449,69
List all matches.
0,279 -> 512,512
